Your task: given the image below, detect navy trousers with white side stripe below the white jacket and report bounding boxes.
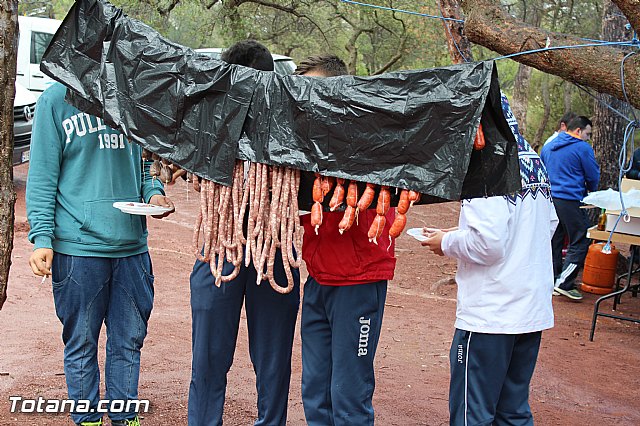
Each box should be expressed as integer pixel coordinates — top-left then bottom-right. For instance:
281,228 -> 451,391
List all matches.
449,329 -> 542,426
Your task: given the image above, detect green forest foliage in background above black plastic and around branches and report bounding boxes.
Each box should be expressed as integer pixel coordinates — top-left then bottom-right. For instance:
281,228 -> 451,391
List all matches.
19,0 -> 624,148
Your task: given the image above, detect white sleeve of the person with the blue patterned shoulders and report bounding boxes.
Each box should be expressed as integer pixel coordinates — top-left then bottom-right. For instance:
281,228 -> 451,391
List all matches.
442,197 -> 511,265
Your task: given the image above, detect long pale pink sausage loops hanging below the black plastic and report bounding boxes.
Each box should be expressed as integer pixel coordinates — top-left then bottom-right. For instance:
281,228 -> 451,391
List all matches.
192,161 -> 303,293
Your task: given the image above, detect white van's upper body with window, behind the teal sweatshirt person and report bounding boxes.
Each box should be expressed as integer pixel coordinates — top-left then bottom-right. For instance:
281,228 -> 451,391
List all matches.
16,16 -> 62,96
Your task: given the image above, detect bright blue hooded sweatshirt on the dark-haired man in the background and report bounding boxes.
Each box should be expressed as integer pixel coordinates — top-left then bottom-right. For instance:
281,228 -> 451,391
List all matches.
540,132 -> 600,201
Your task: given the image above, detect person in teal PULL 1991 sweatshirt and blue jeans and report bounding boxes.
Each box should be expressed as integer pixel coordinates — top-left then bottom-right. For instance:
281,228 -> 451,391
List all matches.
26,83 -> 174,426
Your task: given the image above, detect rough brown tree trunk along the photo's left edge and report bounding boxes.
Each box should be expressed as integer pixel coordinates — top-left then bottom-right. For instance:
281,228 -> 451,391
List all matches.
0,0 -> 18,310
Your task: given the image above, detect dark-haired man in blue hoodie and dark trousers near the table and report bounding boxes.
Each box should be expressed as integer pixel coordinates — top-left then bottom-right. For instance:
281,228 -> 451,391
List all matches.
540,116 -> 600,300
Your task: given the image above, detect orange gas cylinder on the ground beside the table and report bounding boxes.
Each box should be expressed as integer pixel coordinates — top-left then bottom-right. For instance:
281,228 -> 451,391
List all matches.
581,242 -> 620,294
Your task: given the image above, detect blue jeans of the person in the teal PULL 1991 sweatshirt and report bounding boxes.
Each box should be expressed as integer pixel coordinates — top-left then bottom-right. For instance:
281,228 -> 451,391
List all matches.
52,252 -> 153,423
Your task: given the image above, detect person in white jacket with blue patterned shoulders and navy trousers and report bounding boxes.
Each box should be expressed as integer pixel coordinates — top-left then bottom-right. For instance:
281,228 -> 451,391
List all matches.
422,96 -> 558,425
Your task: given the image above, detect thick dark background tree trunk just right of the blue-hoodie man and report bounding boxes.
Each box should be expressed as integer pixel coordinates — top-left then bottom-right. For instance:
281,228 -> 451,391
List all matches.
592,0 -> 630,189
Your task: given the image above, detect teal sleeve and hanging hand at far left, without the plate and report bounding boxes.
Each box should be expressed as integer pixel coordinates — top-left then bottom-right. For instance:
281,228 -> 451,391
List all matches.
26,96 -> 64,276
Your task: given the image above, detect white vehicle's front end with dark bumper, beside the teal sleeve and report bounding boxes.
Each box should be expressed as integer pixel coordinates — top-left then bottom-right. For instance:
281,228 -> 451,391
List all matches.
13,82 -> 36,166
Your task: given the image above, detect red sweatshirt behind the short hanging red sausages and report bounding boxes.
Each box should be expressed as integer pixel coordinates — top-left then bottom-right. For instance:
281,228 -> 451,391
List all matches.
301,208 -> 396,286
